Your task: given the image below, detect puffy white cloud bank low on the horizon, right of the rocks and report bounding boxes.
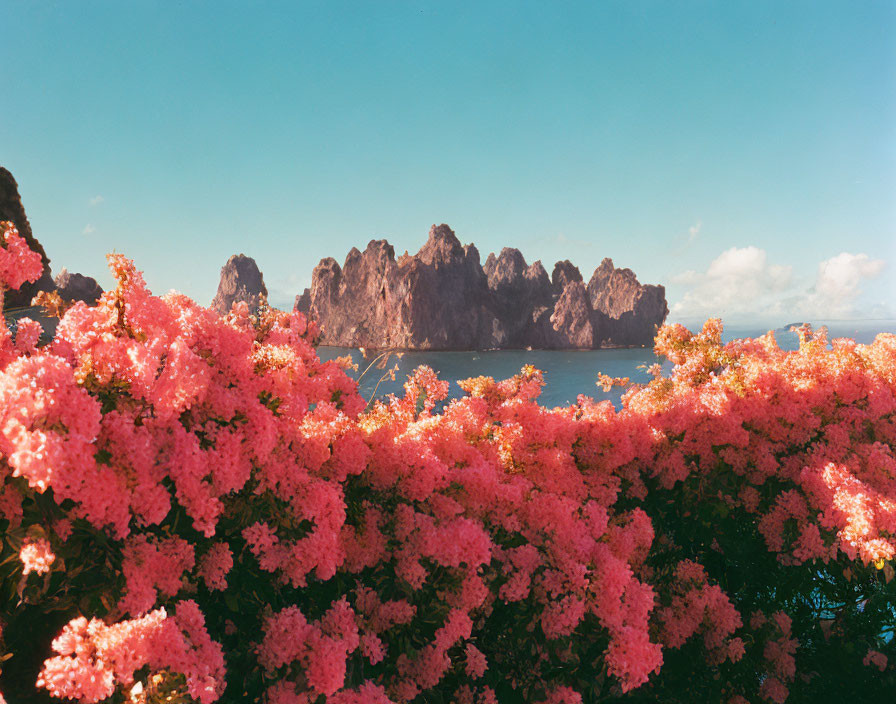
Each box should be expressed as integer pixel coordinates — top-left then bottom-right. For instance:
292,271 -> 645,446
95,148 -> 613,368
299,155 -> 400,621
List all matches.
670,246 -> 892,320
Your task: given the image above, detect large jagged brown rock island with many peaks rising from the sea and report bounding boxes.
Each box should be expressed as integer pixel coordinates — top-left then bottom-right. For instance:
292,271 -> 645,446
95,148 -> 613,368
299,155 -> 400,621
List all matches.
295,225 -> 668,349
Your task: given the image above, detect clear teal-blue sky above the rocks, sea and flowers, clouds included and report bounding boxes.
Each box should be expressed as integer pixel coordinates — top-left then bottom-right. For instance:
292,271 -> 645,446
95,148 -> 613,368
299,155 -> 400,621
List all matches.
0,0 -> 896,324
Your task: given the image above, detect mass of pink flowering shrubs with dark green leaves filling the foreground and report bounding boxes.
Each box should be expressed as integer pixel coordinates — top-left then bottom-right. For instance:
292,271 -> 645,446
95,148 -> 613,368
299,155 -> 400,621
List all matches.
0,221 -> 896,704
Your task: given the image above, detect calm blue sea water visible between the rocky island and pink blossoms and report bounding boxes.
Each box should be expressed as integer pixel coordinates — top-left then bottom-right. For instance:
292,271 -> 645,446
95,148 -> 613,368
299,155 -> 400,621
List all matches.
318,320 -> 896,407
